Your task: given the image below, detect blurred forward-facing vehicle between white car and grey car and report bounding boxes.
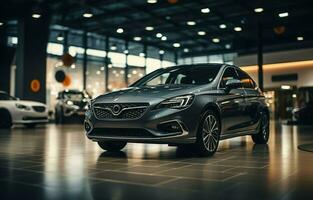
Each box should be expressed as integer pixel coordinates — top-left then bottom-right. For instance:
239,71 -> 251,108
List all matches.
55,90 -> 90,124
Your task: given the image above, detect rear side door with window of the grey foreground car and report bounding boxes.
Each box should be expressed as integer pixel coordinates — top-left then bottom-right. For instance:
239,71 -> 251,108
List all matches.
236,69 -> 261,130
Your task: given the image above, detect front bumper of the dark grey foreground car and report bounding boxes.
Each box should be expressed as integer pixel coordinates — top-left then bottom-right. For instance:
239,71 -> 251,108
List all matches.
85,105 -> 200,144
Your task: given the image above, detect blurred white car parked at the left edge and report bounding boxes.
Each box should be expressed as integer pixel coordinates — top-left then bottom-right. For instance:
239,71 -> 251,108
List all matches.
0,91 -> 48,128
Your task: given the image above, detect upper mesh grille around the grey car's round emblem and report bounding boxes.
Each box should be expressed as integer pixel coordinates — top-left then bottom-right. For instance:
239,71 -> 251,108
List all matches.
94,103 -> 149,120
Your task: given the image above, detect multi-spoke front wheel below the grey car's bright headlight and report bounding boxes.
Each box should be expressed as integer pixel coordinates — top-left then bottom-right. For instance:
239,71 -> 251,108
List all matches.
195,110 -> 221,156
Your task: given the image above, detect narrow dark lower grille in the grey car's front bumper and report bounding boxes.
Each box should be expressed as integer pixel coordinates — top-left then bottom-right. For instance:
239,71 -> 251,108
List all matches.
89,128 -> 155,138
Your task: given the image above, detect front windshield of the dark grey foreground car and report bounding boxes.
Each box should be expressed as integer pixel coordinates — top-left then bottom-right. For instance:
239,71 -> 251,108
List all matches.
132,65 -> 220,87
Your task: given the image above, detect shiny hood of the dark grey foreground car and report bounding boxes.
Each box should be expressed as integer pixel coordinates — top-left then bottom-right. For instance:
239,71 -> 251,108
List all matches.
95,85 -> 202,103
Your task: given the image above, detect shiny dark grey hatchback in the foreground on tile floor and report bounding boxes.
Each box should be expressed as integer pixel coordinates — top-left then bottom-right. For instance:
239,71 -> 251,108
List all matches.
84,64 -> 269,156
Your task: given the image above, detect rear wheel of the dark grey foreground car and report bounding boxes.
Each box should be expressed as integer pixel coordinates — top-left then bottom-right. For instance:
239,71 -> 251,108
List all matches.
251,113 -> 270,144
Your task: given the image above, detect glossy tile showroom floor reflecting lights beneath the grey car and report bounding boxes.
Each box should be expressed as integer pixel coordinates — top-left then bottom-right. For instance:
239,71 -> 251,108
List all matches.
0,123 -> 313,200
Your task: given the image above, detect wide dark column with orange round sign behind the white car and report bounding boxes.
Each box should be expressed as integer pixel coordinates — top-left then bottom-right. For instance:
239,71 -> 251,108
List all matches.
15,9 -> 50,102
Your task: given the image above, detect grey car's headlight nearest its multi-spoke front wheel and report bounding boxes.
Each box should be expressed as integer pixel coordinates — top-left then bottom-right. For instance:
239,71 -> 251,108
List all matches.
156,94 -> 194,109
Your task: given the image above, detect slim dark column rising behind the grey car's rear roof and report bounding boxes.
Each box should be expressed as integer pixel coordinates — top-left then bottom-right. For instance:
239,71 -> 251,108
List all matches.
258,22 -> 264,91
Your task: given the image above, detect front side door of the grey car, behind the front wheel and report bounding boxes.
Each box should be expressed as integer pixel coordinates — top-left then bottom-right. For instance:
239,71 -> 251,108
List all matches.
218,66 -> 245,135
